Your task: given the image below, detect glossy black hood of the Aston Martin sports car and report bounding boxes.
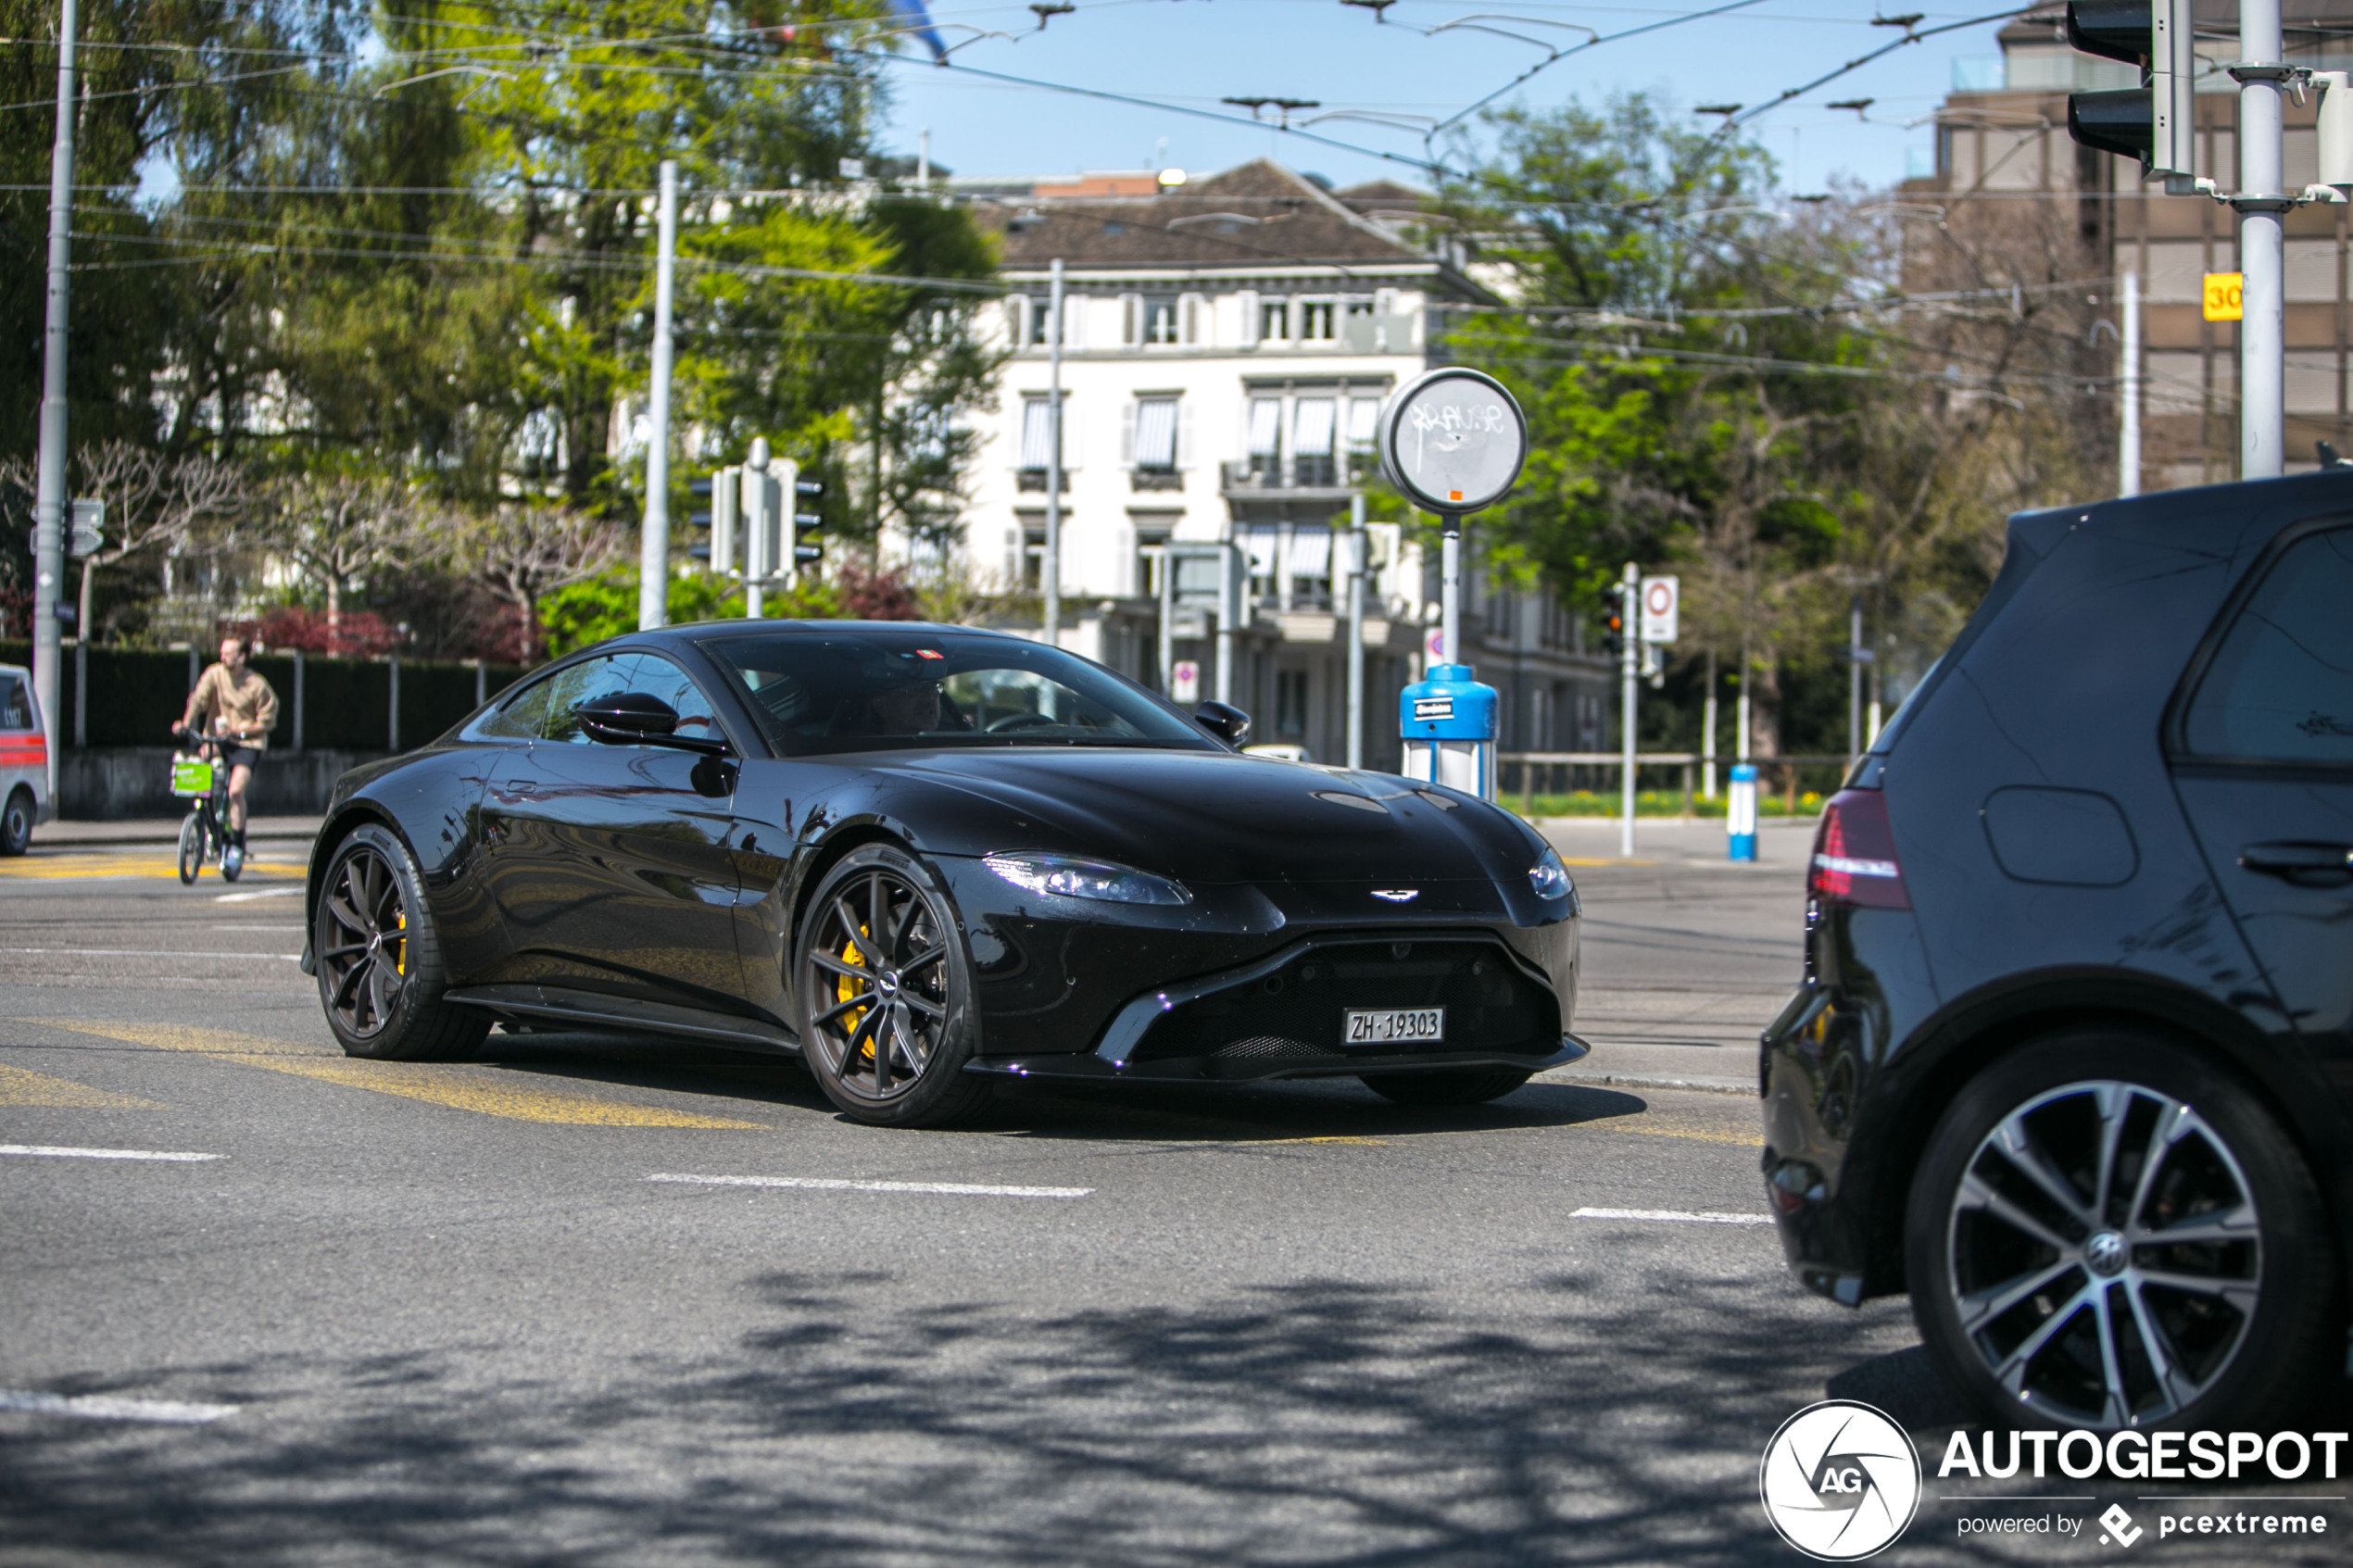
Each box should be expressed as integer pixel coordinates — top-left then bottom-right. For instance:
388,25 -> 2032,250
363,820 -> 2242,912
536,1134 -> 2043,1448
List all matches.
880,747 -> 1543,884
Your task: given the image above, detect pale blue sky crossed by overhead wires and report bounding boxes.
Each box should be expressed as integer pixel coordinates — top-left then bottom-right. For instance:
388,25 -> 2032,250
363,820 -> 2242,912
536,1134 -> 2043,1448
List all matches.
880,0 -> 2000,193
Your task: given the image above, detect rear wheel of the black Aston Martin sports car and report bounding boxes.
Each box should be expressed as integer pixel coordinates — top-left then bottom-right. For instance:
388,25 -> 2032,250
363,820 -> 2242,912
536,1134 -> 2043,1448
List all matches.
310,822 -> 489,1062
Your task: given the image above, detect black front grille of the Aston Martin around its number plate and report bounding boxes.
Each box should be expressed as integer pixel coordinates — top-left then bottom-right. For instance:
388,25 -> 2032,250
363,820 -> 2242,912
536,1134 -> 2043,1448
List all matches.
1129,938 -> 1560,1079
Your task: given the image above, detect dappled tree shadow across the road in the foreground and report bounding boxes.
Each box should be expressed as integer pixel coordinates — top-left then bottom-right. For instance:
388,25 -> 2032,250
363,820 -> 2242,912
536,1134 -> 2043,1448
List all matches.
0,1265 -> 1994,1568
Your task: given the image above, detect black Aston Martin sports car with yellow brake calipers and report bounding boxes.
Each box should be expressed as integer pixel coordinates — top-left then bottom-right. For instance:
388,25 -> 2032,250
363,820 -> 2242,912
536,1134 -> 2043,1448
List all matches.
304,621 -> 1583,1126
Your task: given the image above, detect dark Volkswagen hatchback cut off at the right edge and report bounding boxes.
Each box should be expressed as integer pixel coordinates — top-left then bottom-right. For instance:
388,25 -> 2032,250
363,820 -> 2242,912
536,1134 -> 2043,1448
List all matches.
1762,468 -> 2353,1429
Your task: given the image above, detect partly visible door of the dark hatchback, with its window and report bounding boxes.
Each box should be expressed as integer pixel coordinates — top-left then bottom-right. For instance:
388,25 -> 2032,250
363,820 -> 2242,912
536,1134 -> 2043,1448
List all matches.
2170,524 -> 2353,1110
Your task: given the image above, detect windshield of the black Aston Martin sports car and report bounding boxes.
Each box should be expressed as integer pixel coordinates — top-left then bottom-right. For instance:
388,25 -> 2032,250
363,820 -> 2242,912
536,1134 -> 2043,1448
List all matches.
701,630 -> 1216,757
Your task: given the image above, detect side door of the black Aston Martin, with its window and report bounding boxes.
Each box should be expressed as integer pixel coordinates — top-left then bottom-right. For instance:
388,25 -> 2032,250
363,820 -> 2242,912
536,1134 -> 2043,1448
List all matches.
483,654 -> 744,1013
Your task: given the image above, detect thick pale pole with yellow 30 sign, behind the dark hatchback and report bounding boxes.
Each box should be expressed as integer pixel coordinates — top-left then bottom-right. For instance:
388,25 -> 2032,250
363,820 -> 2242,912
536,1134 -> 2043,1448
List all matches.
2231,0 -> 2296,480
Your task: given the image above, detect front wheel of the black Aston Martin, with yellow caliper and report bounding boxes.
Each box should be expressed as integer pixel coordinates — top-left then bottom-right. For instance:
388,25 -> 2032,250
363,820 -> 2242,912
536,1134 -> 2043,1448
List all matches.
793,844 -> 990,1126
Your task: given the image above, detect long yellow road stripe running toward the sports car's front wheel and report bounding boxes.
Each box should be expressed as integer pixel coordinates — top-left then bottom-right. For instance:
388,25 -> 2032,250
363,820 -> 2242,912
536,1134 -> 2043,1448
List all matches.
26,1018 -> 765,1131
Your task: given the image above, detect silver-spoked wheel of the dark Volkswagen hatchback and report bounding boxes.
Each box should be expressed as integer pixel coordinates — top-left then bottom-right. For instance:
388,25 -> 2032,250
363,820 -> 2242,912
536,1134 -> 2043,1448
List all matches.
1906,1027 -> 2336,1432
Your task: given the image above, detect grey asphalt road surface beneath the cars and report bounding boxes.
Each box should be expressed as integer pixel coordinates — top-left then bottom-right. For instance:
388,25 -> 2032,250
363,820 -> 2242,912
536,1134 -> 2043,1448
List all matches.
0,825 -> 2346,1568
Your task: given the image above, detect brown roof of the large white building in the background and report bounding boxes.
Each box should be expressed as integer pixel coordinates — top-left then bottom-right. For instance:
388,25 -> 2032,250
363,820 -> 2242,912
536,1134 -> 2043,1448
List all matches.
975,157 -> 1438,272
